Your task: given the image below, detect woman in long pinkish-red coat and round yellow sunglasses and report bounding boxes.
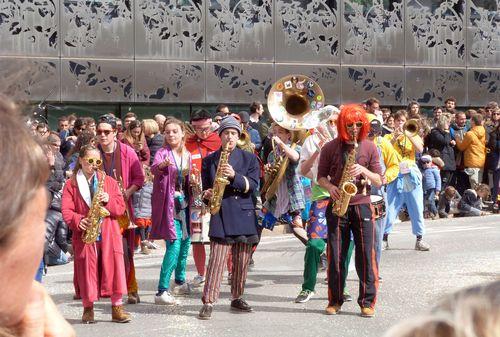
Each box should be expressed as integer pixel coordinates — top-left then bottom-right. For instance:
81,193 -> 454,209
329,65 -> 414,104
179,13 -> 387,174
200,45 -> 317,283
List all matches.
62,145 -> 130,323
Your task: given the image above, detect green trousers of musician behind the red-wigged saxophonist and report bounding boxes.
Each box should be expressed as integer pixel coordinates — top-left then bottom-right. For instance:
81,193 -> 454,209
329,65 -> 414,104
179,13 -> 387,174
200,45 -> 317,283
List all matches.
302,239 -> 354,291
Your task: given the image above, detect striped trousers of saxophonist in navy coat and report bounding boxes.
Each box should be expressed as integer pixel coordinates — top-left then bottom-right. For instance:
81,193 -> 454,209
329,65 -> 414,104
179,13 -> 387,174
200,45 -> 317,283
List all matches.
202,241 -> 253,304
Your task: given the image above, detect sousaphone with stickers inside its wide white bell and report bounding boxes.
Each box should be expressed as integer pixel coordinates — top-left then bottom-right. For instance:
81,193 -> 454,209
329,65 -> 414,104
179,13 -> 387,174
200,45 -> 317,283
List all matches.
261,75 -> 328,199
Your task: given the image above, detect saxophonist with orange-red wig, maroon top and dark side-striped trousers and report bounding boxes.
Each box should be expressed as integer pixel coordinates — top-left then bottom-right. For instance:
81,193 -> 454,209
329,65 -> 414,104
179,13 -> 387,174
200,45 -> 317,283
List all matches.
318,104 -> 382,317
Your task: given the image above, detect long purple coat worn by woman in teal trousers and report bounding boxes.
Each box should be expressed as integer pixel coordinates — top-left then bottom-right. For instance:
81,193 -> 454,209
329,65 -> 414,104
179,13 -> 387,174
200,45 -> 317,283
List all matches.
150,146 -> 191,240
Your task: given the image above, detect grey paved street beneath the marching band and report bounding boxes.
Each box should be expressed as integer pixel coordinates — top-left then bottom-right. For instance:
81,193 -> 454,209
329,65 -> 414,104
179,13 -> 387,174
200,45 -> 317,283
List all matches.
44,215 -> 500,337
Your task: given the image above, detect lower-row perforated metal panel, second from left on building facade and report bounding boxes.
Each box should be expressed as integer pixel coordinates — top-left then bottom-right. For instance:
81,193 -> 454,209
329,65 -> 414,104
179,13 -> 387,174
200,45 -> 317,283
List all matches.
61,60 -> 134,102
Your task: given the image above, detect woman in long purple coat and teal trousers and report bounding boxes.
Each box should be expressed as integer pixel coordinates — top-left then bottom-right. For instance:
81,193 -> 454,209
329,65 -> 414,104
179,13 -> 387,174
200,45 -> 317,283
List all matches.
150,118 -> 191,305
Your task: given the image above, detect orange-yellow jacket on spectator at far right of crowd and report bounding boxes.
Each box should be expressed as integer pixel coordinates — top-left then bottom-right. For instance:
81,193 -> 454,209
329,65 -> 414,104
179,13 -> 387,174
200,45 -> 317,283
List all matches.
456,125 -> 486,168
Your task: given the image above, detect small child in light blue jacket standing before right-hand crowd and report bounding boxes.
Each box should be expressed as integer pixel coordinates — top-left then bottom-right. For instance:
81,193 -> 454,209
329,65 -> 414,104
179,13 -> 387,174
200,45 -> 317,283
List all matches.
420,154 -> 441,220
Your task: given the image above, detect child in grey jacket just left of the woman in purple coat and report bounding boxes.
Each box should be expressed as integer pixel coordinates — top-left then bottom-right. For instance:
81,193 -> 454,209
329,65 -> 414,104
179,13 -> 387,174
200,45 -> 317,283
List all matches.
132,165 -> 155,255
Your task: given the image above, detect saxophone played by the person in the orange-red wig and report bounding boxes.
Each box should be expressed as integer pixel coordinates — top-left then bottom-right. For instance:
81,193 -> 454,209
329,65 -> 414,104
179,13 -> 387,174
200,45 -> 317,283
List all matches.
332,137 -> 358,216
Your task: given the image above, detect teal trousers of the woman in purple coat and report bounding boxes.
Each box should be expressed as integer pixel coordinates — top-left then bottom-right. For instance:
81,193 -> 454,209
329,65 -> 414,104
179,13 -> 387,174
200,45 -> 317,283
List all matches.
158,219 -> 191,291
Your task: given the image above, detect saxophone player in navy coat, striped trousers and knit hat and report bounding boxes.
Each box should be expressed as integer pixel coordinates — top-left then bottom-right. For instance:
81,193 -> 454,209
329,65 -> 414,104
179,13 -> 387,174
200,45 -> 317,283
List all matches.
198,116 -> 259,319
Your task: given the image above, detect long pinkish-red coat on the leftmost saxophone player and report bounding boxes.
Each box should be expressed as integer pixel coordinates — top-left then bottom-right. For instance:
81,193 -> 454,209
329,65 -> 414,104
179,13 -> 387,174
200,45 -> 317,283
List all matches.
62,176 -> 127,302
